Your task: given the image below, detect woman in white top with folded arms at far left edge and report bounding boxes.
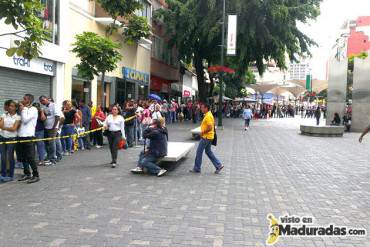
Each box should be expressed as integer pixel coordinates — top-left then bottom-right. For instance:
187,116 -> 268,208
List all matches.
0,100 -> 21,182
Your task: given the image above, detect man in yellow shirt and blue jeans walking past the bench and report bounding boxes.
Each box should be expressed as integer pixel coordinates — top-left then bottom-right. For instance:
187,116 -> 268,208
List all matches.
190,104 -> 224,174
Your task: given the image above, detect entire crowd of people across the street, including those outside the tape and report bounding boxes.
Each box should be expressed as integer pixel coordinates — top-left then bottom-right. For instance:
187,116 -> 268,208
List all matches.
0,94 -> 351,183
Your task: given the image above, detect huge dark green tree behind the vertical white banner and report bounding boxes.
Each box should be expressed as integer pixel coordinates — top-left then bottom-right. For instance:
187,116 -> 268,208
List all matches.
155,0 -> 321,100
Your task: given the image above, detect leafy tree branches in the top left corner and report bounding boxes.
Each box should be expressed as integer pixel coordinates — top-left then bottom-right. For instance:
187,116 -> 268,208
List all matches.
0,0 -> 48,59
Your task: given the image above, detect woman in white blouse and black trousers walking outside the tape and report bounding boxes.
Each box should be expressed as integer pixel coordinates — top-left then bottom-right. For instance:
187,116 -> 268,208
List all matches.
104,106 -> 126,168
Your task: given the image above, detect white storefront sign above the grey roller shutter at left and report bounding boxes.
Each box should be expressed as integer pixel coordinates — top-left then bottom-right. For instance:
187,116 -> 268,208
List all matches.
0,50 -> 55,76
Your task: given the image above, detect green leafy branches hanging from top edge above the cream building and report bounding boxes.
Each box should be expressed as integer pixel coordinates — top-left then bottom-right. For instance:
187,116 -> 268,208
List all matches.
98,0 -> 150,44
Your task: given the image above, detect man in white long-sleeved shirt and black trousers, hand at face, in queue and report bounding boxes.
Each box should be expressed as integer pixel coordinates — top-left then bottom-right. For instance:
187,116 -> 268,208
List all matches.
16,94 -> 40,184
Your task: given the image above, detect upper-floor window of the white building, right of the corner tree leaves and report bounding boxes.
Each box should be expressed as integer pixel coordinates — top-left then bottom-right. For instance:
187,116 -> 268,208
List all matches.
39,0 -> 59,44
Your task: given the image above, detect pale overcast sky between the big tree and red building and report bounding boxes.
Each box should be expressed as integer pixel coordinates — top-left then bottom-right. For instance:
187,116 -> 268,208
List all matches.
300,0 -> 370,79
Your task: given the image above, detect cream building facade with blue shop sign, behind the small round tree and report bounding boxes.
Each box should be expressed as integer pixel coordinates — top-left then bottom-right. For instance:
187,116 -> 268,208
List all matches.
65,0 -> 152,106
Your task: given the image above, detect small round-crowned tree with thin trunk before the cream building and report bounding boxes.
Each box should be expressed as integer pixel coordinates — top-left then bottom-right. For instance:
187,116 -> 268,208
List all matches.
72,32 -> 122,106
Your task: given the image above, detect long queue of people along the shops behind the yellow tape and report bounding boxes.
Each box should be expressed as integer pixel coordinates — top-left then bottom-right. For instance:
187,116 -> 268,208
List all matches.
0,94 -> 205,183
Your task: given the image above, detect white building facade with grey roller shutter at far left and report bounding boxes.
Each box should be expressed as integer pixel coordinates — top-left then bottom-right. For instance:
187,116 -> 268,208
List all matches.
0,0 -> 68,112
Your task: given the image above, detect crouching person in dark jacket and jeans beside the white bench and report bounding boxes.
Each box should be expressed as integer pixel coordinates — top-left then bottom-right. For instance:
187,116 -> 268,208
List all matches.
131,119 -> 168,177
